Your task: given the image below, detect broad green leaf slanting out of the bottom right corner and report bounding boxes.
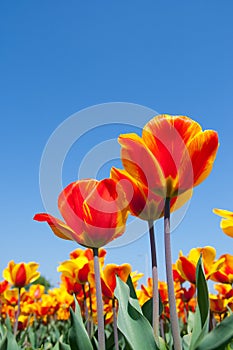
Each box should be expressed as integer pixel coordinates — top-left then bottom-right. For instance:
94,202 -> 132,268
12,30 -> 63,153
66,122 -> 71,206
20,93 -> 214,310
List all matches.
195,314 -> 233,350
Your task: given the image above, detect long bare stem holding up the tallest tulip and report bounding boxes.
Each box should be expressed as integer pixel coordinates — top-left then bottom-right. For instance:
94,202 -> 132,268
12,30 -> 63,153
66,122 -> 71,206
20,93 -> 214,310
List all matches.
164,198 -> 182,350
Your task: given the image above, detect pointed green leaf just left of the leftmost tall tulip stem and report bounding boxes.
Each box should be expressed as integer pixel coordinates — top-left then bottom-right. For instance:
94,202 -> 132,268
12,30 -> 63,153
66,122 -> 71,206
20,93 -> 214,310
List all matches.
68,299 -> 93,350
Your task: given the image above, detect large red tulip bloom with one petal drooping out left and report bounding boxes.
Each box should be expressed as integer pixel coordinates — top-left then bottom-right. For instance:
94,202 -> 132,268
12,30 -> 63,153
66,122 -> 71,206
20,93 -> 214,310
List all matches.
34,179 -> 128,248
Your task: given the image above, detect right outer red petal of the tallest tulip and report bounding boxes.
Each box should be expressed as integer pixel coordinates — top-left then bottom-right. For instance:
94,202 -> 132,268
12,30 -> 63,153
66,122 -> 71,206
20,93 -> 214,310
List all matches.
188,130 -> 218,186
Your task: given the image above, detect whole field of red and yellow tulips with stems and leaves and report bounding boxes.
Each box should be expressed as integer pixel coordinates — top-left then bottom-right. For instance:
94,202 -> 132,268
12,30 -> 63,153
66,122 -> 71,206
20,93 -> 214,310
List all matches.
0,115 -> 233,350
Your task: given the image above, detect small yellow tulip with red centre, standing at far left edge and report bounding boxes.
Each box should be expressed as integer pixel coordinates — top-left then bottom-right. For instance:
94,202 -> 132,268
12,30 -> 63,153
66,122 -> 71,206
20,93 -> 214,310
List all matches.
3,260 -> 40,288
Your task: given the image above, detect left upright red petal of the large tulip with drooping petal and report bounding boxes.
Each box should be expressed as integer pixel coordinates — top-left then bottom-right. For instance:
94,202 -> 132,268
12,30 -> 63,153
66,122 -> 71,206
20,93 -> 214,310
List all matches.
58,179 -> 98,234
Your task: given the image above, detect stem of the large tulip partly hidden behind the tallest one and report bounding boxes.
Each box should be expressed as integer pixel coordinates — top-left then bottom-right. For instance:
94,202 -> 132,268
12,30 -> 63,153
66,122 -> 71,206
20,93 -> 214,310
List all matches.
148,220 -> 159,344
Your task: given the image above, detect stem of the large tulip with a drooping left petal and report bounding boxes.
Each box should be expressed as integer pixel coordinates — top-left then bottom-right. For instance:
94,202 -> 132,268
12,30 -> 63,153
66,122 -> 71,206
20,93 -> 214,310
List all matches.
93,248 -> 105,350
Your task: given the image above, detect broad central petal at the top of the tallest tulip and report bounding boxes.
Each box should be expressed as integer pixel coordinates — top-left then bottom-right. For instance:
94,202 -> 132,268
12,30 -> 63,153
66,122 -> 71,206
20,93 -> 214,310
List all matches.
142,114 -> 201,179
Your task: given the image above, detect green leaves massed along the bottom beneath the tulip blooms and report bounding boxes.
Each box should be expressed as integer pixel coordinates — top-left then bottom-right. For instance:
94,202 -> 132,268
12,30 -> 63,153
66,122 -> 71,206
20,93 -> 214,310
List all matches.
0,257 -> 233,350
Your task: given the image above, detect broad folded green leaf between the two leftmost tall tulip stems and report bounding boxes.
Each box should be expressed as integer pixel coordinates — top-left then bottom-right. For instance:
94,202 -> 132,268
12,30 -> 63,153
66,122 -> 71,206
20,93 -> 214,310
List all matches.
115,276 -> 158,350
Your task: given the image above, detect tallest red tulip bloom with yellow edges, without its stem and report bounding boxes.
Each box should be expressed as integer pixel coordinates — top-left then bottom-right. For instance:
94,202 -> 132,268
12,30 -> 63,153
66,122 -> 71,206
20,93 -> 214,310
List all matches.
116,114 -> 218,200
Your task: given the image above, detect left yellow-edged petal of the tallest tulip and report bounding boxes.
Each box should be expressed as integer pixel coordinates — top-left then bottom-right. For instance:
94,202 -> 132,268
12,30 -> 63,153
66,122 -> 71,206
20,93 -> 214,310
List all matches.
118,134 -> 166,197
